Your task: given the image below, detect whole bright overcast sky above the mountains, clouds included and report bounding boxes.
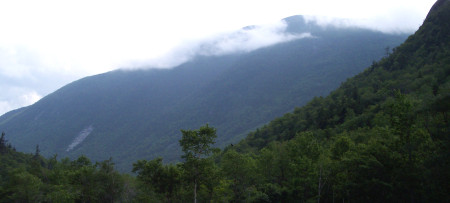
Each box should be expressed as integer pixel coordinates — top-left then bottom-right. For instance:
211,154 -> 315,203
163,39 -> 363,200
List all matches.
0,0 -> 436,115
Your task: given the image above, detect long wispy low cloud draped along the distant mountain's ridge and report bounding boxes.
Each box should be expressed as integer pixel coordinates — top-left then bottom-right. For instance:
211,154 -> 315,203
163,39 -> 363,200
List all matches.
122,20 -> 313,70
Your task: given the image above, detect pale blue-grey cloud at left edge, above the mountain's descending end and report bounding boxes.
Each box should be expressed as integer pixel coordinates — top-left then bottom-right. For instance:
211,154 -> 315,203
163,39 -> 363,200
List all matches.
0,46 -> 76,115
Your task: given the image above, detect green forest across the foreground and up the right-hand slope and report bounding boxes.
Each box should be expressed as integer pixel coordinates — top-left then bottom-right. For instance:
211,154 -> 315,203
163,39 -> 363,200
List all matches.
0,0 -> 450,202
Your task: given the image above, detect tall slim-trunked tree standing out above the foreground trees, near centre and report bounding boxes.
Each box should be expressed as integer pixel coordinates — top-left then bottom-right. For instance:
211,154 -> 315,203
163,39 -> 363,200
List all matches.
180,124 -> 217,203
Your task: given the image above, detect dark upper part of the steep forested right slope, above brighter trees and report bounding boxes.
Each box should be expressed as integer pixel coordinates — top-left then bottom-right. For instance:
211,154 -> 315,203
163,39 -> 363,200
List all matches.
237,2 -> 450,151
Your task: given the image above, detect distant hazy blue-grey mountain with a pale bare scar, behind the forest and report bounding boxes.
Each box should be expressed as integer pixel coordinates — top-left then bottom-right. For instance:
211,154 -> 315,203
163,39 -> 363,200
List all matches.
0,16 -> 406,170
